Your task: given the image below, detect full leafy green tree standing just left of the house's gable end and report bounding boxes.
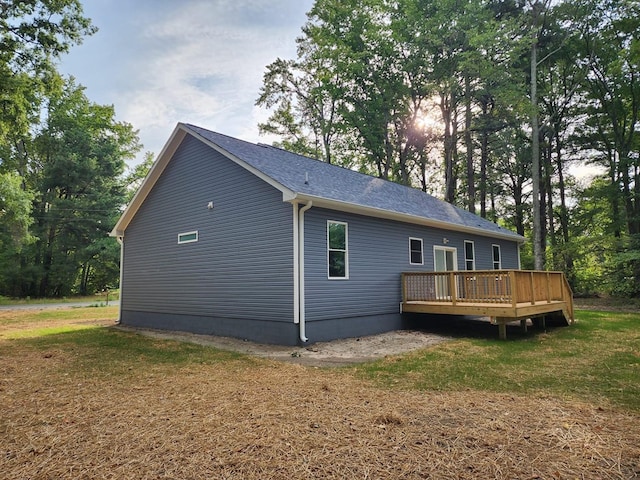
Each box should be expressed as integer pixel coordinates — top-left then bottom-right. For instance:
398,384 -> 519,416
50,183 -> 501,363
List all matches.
21,79 -> 140,297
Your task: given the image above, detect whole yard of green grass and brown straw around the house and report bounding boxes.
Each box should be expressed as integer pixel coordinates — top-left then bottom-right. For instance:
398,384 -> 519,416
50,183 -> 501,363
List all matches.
0,307 -> 640,479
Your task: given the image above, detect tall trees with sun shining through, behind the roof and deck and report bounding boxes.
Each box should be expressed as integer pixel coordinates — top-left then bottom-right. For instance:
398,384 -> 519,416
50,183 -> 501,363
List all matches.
256,0 -> 640,295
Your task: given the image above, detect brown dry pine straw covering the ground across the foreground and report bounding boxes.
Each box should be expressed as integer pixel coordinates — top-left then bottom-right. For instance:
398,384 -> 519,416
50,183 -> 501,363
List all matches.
0,348 -> 640,480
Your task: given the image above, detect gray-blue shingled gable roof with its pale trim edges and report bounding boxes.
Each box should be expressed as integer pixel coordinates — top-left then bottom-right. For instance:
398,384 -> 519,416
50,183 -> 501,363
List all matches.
112,123 -> 524,242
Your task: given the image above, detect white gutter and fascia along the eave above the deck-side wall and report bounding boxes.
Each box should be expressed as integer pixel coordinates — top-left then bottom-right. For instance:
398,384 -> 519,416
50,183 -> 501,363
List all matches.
284,194 -> 526,244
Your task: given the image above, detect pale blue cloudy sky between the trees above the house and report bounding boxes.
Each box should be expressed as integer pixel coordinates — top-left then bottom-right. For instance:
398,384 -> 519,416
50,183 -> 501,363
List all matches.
59,0 -> 313,165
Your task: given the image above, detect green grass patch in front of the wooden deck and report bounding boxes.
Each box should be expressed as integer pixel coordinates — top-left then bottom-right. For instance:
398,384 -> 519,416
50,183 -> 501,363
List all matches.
354,311 -> 640,410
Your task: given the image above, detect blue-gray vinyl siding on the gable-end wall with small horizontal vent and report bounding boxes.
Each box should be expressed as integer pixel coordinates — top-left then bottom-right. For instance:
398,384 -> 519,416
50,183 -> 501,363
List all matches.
122,135 -> 293,334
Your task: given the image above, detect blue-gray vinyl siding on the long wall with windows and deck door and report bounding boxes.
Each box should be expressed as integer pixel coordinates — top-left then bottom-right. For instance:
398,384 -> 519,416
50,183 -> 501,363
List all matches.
305,208 -> 518,323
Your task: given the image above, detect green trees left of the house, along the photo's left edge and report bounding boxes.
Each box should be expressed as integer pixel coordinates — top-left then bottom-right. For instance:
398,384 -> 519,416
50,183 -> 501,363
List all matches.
0,0 -> 141,297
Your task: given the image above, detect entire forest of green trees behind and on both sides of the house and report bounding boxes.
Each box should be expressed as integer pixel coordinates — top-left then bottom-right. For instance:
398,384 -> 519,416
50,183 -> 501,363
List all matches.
0,0 -> 640,297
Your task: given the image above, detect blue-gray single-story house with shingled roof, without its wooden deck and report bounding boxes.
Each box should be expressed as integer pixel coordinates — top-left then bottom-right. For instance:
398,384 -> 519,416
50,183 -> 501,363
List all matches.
112,123 -> 524,345
